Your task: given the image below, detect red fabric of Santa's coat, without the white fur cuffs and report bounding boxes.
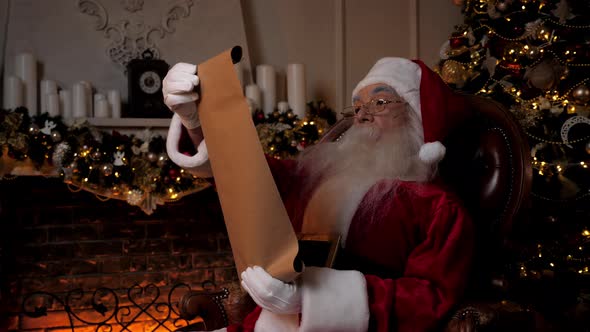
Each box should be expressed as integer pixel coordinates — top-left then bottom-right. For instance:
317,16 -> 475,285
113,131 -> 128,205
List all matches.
228,159 -> 474,331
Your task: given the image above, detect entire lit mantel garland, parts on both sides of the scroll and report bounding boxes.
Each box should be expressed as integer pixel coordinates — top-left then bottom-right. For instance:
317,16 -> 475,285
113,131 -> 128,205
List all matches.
0,101 -> 336,214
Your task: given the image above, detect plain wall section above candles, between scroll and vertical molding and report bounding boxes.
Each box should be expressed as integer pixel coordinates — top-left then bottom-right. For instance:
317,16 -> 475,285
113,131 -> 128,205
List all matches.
242,0 -> 336,110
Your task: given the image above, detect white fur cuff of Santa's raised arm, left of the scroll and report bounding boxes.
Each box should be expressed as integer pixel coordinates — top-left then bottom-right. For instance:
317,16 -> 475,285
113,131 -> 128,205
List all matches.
166,114 -> 213,177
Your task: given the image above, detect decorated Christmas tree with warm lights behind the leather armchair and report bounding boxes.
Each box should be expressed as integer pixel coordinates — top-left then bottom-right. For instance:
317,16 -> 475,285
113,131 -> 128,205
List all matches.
436,0 -> 590,326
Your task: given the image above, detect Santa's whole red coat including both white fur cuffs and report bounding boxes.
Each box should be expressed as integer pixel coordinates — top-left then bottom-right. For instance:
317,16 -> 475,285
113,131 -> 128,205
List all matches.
167,116 -> 474,332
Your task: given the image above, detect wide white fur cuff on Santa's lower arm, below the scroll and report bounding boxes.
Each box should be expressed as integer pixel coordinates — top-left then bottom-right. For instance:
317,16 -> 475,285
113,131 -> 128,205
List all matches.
300,267 -> 370,332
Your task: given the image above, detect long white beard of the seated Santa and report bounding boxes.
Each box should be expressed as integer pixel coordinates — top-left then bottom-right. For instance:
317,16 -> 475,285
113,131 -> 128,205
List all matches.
299,111 -> 432,243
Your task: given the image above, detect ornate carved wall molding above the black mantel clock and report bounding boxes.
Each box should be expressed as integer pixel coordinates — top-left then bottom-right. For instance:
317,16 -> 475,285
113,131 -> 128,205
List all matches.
74,0 -> 194,68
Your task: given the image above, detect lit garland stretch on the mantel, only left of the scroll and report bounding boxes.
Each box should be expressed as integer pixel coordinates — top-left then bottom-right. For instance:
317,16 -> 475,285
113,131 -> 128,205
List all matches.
0,107 -> 210,214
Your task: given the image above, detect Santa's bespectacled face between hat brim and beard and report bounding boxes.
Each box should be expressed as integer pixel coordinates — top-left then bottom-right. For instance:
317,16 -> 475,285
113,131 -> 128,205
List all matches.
352,83 -> 408,139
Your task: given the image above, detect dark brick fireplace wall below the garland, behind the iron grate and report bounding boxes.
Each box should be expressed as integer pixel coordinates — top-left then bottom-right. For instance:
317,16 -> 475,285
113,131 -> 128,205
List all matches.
0,177 -> 245,331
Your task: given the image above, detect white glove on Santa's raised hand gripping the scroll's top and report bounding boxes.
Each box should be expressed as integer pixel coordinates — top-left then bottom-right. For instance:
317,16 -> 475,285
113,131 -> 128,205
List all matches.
162,62 -> 201,129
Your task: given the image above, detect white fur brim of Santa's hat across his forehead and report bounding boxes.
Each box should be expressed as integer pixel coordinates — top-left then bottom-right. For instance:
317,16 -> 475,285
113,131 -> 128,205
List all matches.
352,58 -> 422,121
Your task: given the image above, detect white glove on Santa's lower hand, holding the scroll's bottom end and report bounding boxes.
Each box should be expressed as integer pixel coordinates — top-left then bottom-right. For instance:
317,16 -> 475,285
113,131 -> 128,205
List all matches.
242,266 -> 301,314
